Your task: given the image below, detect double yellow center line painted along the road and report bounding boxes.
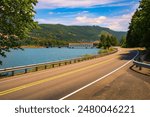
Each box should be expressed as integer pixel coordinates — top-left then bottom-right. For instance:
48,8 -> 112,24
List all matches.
0,57 -> 118,96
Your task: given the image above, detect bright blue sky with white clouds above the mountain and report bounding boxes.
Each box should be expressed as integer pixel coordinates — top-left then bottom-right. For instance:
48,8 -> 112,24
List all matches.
35,0 -> 139,31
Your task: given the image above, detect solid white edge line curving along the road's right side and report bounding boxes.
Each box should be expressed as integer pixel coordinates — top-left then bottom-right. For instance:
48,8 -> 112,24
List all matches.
59,51 -> 139,100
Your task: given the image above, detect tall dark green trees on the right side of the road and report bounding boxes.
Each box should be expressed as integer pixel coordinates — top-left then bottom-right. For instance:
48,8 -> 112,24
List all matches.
127,0 -> 150,49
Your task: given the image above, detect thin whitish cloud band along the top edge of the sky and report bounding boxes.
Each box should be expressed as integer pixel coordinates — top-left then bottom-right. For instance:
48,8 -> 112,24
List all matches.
36,0 -> 122,9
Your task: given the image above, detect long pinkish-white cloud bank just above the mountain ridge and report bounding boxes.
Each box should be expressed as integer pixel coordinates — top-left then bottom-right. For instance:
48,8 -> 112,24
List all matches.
36,13 -> 133,31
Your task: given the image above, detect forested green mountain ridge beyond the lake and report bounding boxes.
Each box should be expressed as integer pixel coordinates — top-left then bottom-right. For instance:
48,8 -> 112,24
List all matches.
31,24 -> 126,42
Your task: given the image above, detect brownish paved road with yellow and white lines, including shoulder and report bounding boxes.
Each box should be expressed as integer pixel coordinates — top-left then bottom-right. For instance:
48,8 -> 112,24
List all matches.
0,48 -> 150,100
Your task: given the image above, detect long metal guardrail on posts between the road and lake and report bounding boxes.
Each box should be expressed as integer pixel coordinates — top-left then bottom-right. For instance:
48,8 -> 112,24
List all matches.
0,49 -> 118,76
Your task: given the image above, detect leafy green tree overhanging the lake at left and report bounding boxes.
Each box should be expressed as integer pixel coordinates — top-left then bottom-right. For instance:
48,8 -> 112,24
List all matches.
0,0 -> 37,64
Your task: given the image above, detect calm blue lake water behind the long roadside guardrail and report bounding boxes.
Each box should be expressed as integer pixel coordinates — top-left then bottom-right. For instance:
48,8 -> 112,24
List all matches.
0,48 -> 98,69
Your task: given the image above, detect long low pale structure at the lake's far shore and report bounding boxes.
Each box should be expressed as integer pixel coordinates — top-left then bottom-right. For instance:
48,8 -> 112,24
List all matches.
69,42 -> 94,48
